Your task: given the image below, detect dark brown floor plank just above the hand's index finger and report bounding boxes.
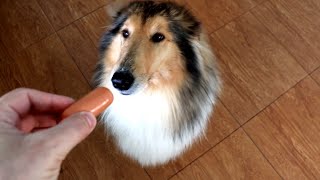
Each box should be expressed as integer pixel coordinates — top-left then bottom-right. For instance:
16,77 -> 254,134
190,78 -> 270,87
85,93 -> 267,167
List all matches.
15,35 -> 90,98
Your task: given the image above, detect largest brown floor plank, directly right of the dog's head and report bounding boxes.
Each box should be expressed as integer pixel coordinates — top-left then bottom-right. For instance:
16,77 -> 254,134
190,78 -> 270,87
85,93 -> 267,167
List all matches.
212,13 -> 306,124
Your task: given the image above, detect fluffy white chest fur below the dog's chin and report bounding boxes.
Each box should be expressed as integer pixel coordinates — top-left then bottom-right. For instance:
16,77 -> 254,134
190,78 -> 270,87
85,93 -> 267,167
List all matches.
102,87 -> 198,166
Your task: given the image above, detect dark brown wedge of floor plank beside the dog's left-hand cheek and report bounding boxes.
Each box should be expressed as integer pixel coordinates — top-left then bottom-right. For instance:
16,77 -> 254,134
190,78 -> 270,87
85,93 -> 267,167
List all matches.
58,7 -> 111,82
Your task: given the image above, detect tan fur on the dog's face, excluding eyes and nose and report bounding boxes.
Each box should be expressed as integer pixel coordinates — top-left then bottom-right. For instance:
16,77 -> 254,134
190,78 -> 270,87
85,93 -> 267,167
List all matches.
104,14 -> 186,91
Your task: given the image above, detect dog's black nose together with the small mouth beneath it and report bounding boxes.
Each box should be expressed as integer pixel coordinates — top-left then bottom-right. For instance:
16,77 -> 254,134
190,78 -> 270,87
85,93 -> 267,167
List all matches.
111,68 -> 137,95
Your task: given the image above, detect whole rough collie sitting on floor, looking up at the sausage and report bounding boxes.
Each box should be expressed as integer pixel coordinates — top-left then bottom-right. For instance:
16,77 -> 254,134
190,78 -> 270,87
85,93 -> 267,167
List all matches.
94,1 -> 220,166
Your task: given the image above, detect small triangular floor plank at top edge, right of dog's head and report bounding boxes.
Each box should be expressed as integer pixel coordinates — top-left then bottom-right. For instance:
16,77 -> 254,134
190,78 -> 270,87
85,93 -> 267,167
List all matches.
187,0 -> 257,32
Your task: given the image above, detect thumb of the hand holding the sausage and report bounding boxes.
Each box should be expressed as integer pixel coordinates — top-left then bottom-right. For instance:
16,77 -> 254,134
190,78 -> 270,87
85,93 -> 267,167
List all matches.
37,112 -> 97,159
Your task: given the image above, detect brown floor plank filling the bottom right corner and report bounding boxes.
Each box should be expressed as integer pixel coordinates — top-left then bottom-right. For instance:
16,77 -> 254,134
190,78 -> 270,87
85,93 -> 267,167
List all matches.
244,77 -> 320,179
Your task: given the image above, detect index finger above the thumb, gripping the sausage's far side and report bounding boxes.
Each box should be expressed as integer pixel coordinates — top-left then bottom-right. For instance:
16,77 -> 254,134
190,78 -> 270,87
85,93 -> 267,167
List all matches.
0,88 -> 74,117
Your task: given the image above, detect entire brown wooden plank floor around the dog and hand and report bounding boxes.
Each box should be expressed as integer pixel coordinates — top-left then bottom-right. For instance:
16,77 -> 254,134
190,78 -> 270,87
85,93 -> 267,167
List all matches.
0,0 -> 320,180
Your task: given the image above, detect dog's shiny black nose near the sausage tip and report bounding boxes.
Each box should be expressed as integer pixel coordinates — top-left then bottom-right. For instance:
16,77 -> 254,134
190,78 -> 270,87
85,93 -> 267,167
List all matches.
111,70 -> 134,91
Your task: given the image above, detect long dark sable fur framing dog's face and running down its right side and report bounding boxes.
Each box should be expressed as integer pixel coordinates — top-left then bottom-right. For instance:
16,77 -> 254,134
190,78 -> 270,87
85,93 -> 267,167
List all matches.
93,1 -> 221,166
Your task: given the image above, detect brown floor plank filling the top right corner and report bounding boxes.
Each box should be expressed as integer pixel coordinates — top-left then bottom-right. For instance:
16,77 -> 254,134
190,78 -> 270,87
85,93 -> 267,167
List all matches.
252,0 -> 320,73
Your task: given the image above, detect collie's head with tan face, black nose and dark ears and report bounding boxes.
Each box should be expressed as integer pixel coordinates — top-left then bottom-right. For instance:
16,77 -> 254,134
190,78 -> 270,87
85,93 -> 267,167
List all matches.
95,1 -> 200,95
